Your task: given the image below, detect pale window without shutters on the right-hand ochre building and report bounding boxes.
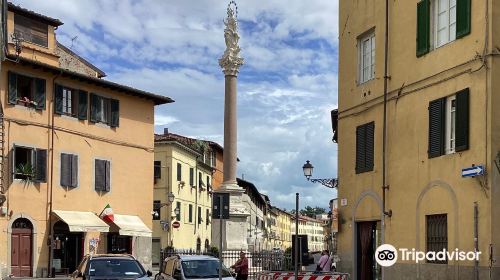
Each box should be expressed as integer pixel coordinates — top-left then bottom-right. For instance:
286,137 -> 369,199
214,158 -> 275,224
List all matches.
358,31 -> 375,84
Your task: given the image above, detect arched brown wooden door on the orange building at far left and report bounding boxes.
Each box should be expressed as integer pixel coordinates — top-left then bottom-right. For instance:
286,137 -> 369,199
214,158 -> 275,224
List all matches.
11,218 -> 33,277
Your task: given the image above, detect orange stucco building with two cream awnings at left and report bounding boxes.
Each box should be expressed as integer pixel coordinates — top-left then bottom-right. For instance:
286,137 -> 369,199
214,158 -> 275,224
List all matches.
0,1 -> 172,278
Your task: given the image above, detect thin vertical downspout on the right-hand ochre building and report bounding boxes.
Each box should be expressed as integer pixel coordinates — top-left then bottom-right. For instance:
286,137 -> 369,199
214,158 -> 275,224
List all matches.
382,0 -> 392,217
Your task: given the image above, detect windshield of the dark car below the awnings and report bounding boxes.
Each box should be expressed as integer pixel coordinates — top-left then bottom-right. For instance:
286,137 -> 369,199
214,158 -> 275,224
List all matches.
89,259 -> 146,278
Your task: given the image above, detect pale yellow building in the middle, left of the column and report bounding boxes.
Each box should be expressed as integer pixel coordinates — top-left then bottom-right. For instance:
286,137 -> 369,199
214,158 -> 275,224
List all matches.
153,129 -> 214,261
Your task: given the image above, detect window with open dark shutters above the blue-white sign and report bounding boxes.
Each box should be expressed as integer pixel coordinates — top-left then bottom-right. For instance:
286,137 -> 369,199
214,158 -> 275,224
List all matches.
428,89 -> 469,158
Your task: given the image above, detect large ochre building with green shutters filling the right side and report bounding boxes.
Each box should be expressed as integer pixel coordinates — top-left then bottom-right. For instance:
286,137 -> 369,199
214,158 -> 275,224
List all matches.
337,0 -> 500,279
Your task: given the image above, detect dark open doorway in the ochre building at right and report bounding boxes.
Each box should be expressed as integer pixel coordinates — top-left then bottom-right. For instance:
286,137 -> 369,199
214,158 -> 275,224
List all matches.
356,221 -> 382,280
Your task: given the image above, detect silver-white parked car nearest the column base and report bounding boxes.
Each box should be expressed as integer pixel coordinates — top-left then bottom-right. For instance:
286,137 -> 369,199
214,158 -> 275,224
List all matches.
155,255 -> 234,280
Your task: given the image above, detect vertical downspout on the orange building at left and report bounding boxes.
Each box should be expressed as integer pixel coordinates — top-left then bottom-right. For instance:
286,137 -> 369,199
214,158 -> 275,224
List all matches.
47,71 -> 62,277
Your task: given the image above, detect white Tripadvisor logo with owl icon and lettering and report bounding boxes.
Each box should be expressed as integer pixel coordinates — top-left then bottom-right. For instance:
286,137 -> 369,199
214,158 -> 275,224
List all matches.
375,244 -> 481,267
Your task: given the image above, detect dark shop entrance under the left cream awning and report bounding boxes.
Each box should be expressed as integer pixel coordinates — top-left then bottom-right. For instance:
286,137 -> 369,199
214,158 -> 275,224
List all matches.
52,221 -> 84,274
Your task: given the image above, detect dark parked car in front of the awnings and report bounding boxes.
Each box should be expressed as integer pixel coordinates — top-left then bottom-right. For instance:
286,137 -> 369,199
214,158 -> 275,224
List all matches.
71,254 -> 153,280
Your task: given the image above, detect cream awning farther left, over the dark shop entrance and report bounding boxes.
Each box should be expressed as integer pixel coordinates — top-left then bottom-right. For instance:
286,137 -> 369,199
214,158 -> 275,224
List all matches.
52,210 -> 109,232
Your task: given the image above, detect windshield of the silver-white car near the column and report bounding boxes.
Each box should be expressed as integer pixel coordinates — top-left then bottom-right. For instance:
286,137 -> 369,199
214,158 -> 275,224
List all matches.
181,260 -> 231,278
